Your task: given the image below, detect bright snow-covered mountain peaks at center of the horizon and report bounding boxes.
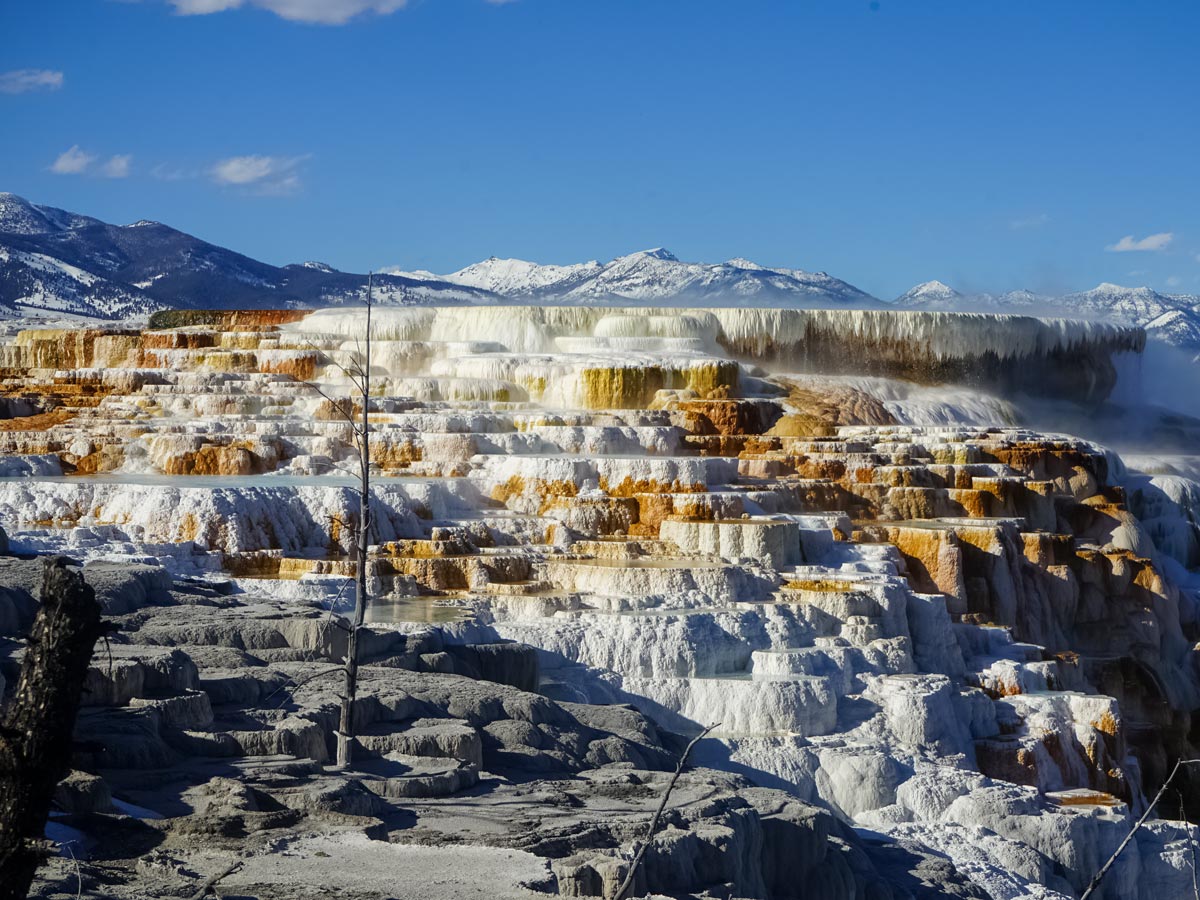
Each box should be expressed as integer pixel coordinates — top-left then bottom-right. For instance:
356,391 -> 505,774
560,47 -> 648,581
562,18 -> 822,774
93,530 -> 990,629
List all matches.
417,247 -> 880,307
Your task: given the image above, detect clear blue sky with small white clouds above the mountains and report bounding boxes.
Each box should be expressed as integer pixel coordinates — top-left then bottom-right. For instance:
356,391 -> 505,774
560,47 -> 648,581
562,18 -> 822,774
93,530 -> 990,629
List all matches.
0,0 -> 1200,298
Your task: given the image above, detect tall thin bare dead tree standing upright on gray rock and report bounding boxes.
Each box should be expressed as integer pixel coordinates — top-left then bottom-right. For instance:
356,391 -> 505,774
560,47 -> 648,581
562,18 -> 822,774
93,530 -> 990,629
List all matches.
337,275 -> 372,768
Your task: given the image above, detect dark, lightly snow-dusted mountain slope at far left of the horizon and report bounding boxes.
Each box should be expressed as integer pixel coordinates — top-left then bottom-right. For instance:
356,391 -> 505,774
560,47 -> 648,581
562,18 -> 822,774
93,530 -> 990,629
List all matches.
0,193 -> 499,318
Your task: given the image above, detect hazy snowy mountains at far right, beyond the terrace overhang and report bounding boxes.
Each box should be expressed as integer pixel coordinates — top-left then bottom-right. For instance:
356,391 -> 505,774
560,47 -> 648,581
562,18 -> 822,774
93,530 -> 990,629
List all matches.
893,281 -> 1200,353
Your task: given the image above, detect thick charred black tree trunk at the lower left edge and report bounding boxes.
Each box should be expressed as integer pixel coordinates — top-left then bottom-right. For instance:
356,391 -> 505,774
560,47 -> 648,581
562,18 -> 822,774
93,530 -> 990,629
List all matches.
0,557 -> 104,900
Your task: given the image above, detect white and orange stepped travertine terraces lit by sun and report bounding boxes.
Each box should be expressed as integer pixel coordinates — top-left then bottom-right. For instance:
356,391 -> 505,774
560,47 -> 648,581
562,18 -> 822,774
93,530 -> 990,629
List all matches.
0,307 -> 1200,900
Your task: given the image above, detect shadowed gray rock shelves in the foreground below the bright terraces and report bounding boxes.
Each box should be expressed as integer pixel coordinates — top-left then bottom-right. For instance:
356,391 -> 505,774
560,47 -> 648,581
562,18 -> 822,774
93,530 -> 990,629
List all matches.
5,560 -> 974,900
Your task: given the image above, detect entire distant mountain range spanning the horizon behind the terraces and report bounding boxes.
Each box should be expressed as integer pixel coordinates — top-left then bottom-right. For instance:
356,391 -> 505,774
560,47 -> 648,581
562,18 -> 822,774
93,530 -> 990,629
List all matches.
0,193 -> 1200,354
